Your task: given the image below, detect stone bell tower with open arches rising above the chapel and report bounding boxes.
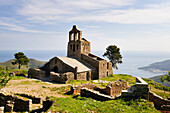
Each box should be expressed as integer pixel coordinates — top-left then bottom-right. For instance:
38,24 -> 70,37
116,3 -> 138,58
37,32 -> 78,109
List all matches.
67,25 -> 90,59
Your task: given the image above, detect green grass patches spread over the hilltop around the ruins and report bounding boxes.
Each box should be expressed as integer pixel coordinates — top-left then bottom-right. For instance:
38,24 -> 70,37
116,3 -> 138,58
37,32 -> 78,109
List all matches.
0,67 -> 170,113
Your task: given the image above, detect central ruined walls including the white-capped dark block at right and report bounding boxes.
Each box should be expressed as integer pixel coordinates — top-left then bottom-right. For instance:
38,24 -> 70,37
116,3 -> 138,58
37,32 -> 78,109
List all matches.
71,77 -> 149,101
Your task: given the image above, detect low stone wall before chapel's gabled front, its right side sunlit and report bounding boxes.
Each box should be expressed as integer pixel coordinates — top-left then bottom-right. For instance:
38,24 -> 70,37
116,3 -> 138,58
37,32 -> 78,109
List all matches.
50,72 -> 74,83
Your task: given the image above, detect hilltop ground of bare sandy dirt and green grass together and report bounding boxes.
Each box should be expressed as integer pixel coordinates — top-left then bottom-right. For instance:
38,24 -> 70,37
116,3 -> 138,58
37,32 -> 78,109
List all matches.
3,74 -> 167,113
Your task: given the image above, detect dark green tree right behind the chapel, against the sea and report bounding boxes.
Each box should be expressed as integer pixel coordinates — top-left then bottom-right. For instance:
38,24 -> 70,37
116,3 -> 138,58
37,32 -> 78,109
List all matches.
103,45 -> 123,69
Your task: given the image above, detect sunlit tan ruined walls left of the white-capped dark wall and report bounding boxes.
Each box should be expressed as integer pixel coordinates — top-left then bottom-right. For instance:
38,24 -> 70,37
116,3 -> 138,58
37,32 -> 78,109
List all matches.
71,80 -> 128,101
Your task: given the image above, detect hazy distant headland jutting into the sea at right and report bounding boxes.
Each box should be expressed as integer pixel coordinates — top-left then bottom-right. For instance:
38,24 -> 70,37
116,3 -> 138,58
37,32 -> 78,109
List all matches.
138,60 -> 170,73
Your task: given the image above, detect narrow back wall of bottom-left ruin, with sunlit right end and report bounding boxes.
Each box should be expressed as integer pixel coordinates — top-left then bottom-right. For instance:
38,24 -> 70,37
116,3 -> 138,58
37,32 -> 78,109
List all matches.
15,93 -> 42,104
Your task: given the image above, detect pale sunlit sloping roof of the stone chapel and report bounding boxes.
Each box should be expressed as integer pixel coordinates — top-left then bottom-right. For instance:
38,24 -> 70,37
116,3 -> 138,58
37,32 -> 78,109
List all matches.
58,57 -> 92,72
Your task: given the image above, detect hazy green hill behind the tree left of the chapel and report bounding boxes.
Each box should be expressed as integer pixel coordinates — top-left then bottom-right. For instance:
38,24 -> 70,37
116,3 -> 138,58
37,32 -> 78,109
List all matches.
0,58 -> 46,70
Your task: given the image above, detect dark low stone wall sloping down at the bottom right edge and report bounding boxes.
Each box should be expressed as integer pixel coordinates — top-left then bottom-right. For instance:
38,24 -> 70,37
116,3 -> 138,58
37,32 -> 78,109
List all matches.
149,91 -> 170,111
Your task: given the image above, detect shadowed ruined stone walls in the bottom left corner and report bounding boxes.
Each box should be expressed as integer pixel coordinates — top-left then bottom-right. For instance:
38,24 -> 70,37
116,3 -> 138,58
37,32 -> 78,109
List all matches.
0,92 -> 53,113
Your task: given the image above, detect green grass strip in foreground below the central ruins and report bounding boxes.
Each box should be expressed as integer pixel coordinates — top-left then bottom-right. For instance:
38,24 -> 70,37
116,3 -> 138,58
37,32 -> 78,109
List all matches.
49,96 -> 159,113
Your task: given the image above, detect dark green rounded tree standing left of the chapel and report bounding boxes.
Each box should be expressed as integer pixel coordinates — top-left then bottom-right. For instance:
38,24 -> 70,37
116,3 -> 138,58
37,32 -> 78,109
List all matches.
12,52 -> 29,69
